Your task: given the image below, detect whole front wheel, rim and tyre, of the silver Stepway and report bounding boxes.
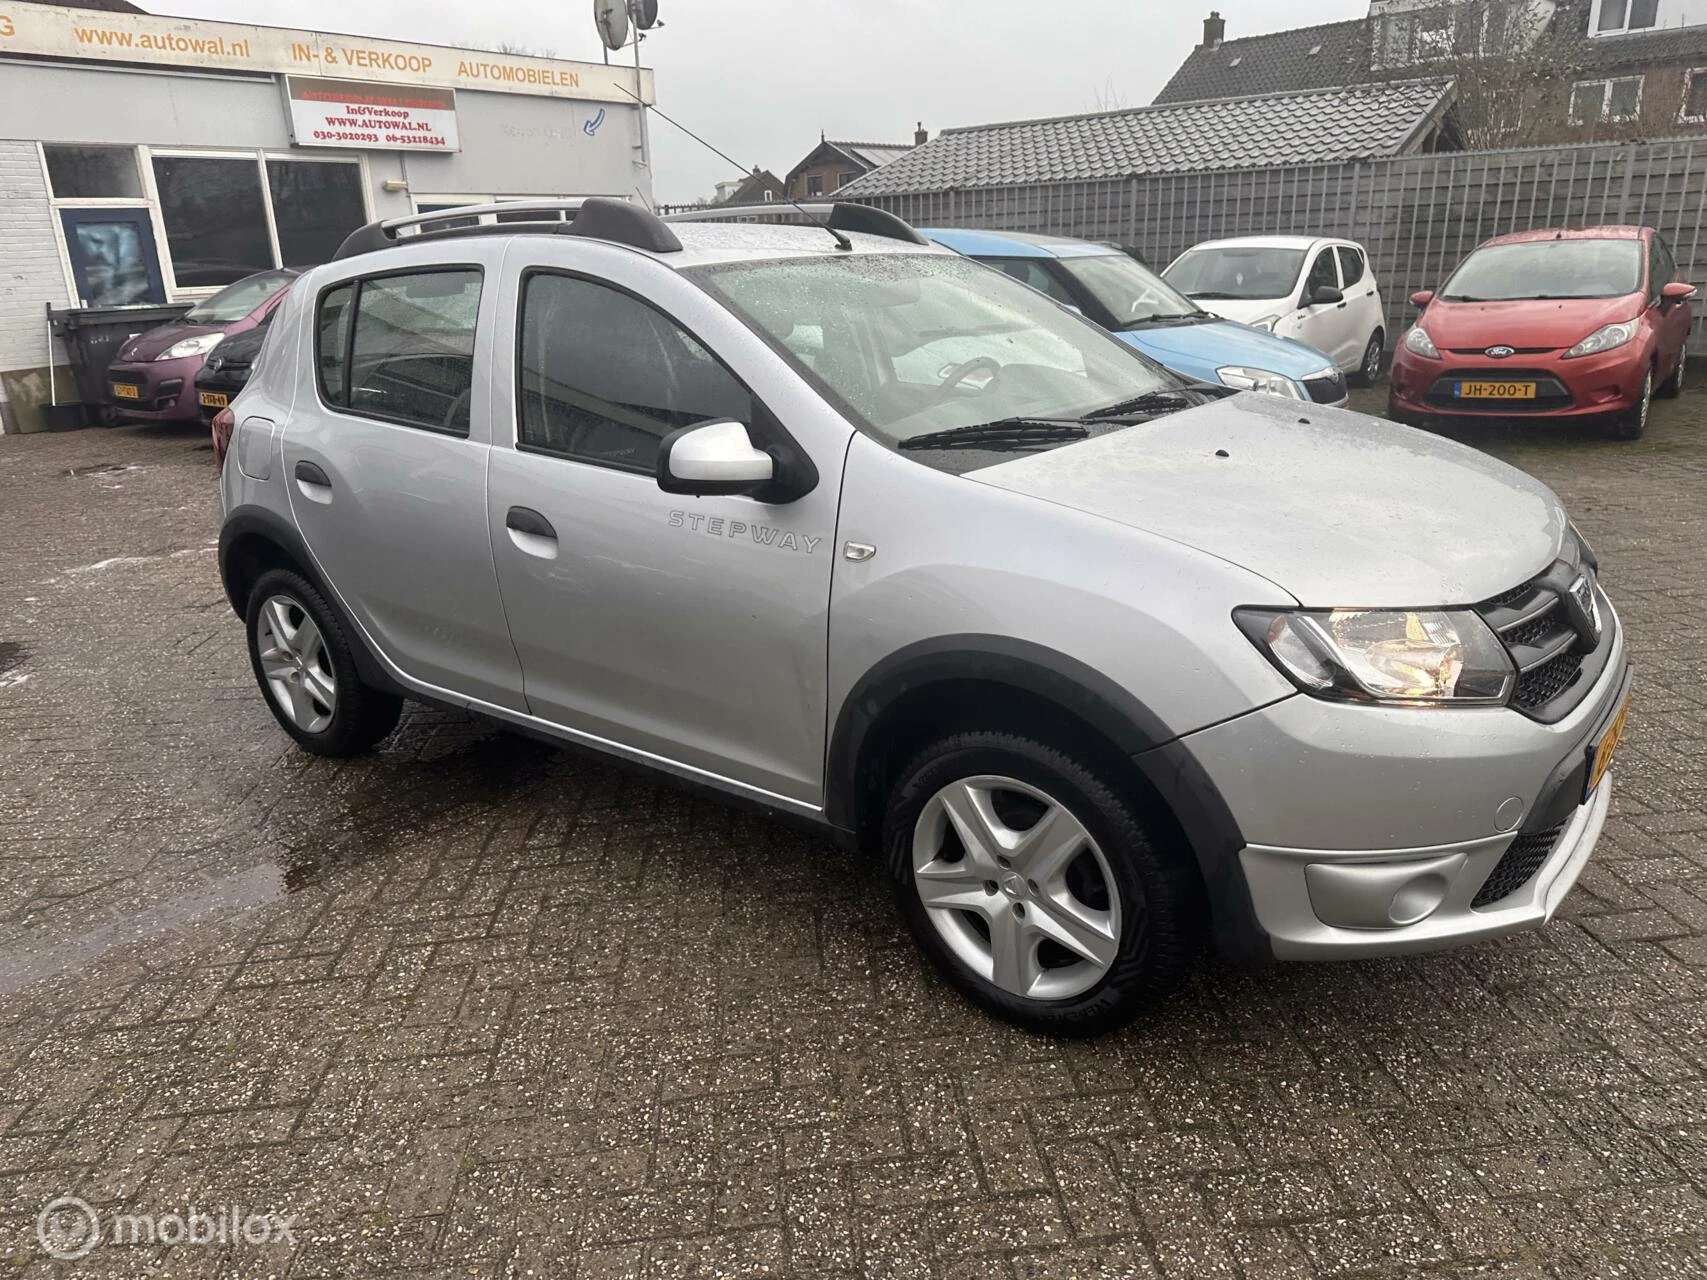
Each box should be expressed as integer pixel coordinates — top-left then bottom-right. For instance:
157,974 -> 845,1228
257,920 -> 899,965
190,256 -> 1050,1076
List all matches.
886,734 -> 1198,1034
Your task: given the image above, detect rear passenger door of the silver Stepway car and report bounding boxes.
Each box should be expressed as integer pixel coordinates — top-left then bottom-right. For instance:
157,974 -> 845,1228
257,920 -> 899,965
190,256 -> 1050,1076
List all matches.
283,244 -> 524,710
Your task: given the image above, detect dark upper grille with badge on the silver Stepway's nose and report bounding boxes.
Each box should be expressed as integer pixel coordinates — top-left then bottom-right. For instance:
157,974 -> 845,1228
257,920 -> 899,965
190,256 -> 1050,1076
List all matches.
1477,541 -> 1608,720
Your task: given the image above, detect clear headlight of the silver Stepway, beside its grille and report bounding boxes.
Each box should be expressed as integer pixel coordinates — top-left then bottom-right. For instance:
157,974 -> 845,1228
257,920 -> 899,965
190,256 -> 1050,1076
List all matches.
1232,609 -> 1516,705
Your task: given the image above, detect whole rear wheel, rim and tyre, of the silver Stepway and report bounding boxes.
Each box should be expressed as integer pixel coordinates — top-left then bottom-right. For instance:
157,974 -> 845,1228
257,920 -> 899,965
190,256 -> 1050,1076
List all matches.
248,568 -> 403,756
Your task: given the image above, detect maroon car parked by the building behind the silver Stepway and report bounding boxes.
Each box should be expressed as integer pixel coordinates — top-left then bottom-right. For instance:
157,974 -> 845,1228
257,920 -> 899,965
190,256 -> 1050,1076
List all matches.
108,270 -> 297,422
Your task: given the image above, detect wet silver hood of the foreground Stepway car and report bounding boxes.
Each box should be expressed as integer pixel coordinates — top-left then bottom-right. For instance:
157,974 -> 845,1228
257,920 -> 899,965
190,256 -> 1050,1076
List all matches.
968,393 -> 1567,608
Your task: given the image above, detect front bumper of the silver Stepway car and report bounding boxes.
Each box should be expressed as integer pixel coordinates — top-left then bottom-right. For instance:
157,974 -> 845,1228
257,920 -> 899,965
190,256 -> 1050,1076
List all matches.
1164,596 -> 1630,959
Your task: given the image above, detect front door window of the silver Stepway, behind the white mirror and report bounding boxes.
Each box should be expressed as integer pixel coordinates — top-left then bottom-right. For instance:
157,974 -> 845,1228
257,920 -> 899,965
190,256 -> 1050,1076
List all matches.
517,273 -> 753,474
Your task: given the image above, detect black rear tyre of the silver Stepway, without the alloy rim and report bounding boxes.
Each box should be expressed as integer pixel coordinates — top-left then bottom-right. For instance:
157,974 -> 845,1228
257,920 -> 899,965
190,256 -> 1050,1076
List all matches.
244,568 -> 403,759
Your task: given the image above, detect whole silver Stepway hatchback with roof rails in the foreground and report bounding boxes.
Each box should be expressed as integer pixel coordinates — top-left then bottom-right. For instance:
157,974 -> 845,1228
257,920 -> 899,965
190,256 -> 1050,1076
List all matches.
220,200 -> 1628,1034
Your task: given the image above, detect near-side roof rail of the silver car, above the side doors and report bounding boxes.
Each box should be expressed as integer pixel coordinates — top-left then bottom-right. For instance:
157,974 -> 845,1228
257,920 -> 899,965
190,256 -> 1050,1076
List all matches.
333,196 -> 681,261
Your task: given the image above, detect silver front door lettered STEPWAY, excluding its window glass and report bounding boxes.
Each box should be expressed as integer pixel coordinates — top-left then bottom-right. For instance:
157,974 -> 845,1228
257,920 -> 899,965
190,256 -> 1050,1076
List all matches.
490,256 -> 847,806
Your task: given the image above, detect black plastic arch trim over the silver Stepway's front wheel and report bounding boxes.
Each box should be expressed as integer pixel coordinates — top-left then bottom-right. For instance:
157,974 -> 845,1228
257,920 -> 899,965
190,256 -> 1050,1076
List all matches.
824,635 -> 1273,966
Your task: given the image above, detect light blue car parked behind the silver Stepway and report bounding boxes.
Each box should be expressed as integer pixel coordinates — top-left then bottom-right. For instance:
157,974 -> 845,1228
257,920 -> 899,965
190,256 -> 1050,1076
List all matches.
918,227 -> 1345,404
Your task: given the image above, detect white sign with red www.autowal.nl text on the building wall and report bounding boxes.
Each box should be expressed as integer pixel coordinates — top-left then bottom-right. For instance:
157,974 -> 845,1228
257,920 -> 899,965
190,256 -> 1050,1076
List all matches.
285,75 -> 459,152
